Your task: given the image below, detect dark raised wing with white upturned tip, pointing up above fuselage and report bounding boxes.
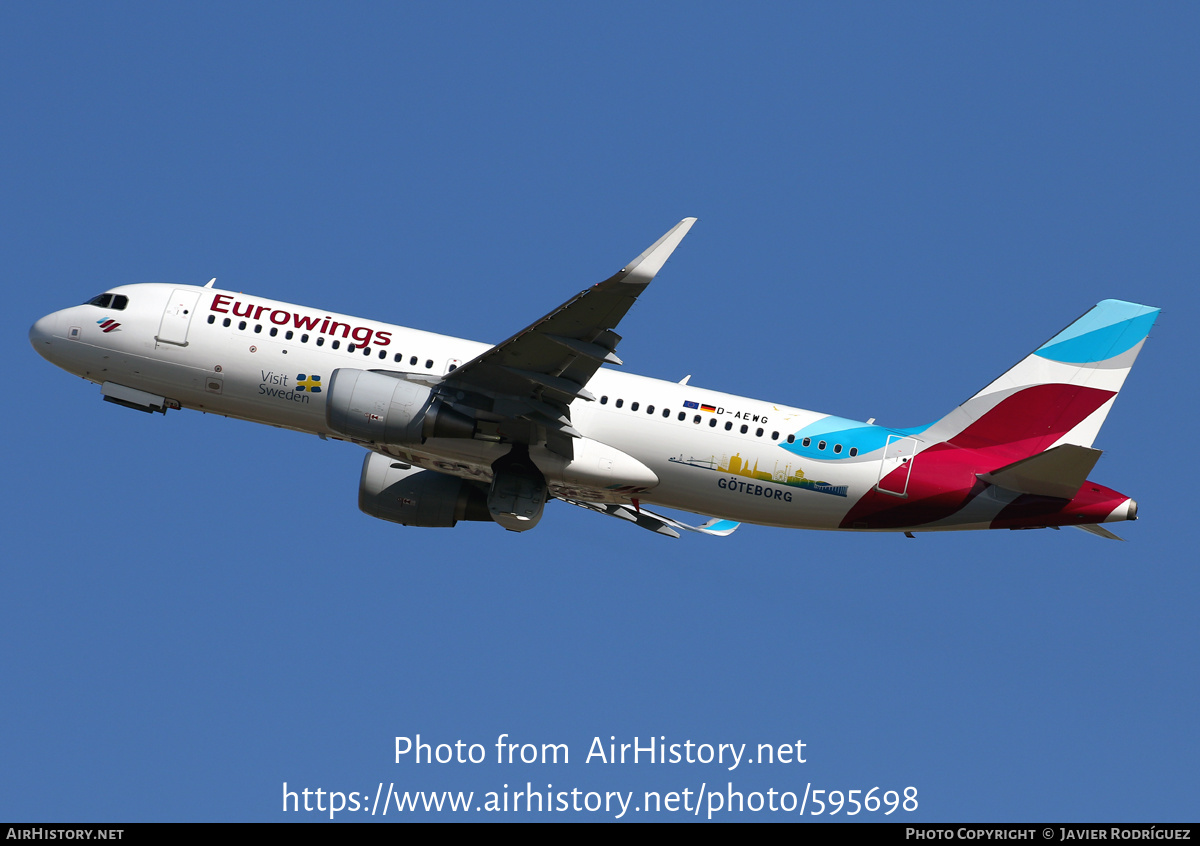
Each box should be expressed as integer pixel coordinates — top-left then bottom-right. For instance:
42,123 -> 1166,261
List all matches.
438,217 -> 696,457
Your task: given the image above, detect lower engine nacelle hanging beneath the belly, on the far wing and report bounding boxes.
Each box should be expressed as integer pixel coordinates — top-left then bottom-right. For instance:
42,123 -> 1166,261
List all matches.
359,452 -> 492,528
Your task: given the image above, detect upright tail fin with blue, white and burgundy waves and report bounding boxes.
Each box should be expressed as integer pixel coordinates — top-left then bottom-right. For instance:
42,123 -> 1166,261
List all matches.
923,300 -> 1159,461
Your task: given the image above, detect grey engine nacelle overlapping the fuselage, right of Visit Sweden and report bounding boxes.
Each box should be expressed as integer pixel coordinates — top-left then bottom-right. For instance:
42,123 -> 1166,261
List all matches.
325,367 -> 475,444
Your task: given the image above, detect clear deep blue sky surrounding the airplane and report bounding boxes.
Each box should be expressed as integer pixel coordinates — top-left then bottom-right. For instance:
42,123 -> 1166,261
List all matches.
0,2 -> 1200,822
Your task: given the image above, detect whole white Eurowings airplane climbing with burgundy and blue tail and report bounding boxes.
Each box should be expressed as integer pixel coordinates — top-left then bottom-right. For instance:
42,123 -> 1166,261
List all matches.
29,217 -> 1159,540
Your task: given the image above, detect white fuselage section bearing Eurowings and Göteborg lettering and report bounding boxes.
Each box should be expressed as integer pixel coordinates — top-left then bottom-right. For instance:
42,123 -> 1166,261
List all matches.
30,284 -> 892,528
